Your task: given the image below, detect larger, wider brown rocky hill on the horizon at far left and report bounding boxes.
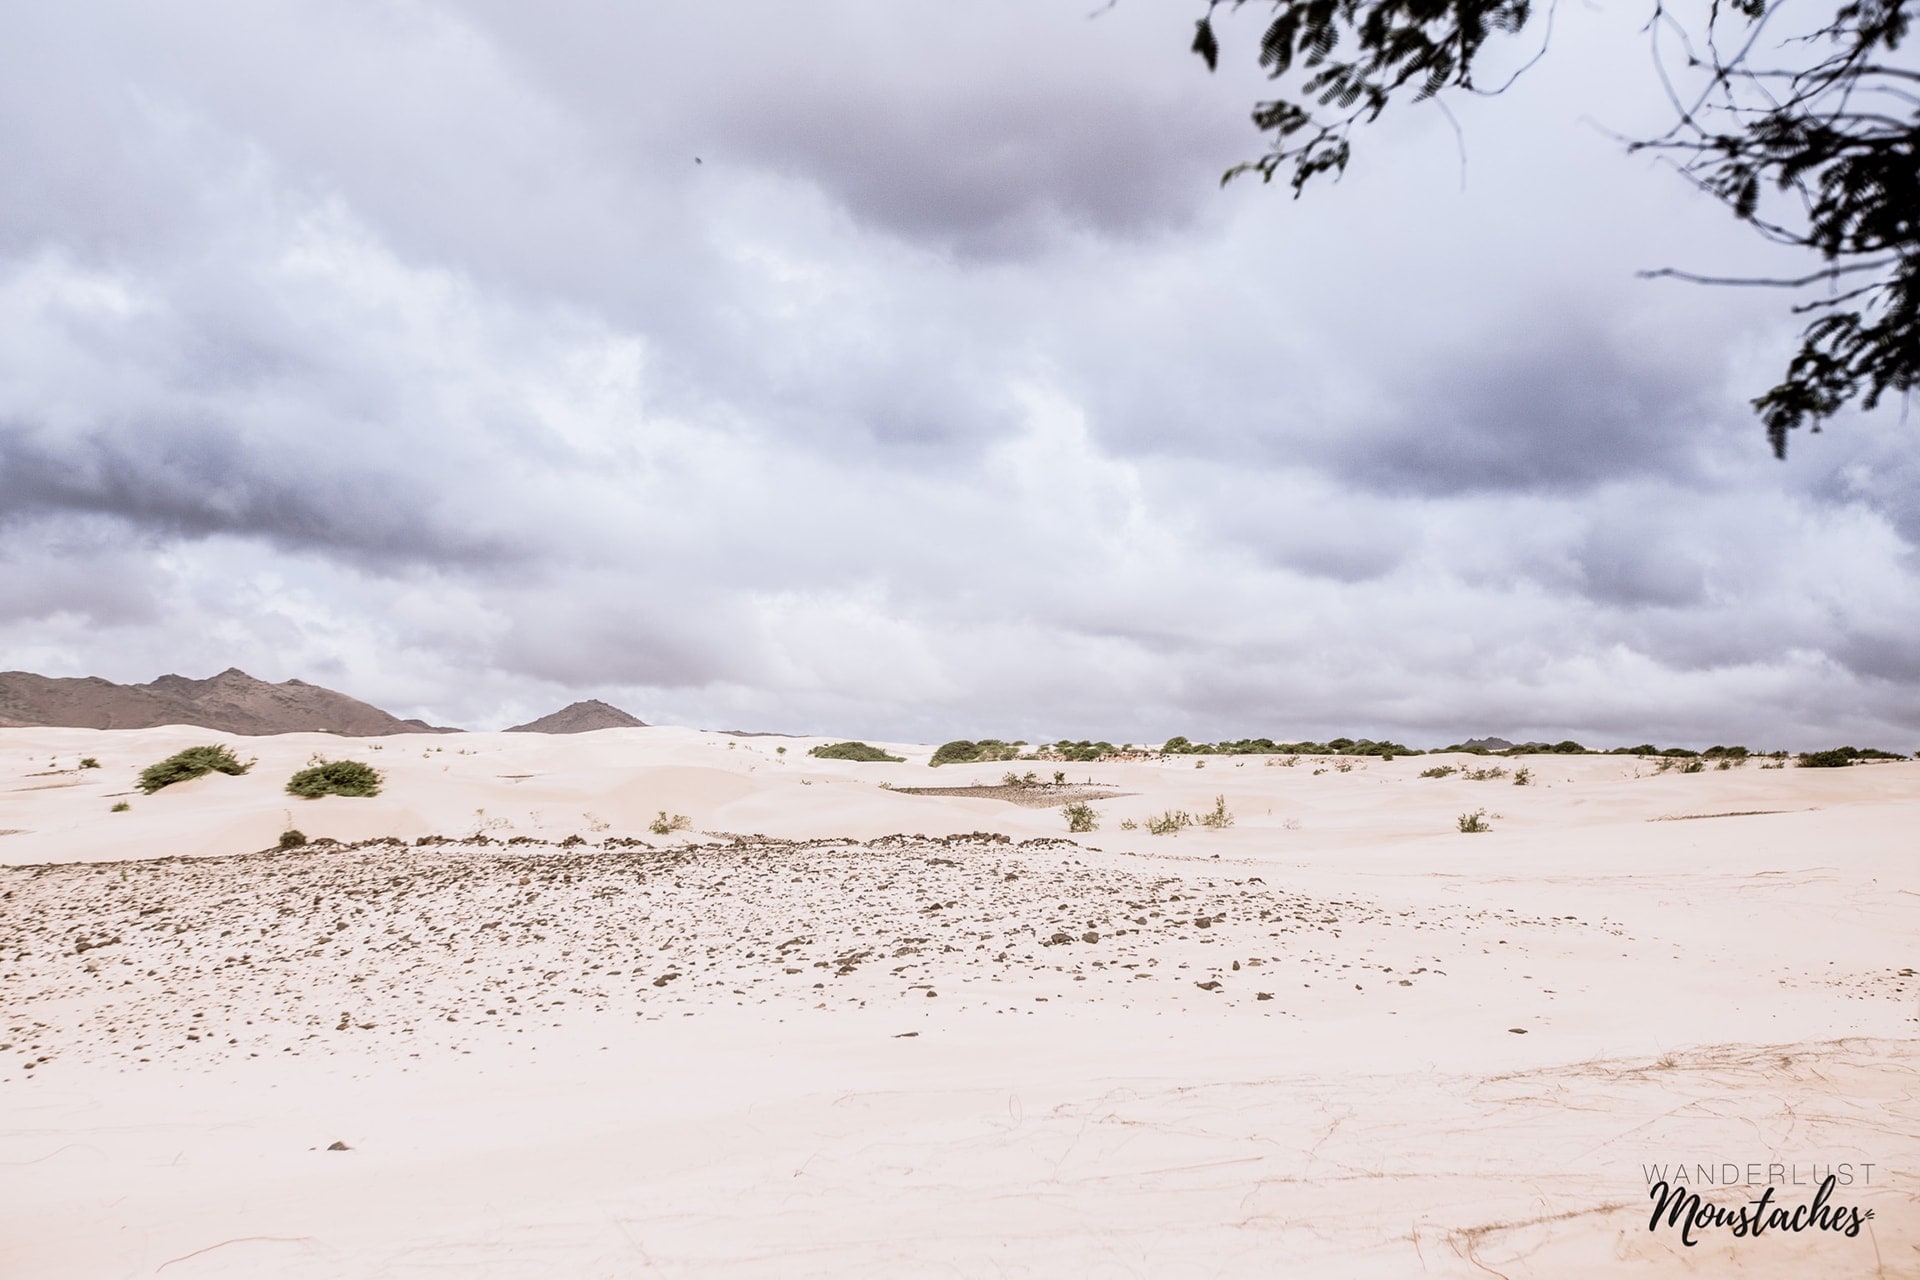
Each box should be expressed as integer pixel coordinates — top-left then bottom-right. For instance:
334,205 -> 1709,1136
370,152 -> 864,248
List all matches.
0,668 -> 459,737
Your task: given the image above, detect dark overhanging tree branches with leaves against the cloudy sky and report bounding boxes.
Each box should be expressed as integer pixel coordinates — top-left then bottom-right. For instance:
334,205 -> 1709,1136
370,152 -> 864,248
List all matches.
1192,0 -> 1920,457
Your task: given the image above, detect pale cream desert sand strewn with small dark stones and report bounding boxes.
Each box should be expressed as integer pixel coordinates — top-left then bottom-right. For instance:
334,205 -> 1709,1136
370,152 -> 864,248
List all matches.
0,727 -> 1920,1278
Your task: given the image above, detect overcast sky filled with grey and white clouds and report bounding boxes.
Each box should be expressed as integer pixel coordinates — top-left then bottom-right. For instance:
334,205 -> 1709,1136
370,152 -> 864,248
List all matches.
0,0 -> 1920,750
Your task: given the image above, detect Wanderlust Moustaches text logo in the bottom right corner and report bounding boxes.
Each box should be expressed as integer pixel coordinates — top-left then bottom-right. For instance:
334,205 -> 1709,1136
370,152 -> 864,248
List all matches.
1640,1163 -> 1874,1247
